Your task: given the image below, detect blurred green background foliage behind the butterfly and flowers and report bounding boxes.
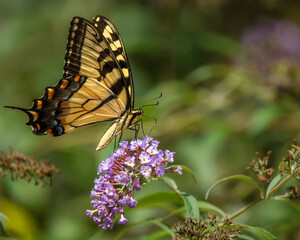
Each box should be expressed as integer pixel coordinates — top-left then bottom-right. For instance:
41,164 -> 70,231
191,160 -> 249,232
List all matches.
0,0 -> 300,240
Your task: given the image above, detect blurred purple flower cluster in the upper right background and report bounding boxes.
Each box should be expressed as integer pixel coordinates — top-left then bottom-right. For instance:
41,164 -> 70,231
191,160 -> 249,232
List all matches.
242,18 -> 300,71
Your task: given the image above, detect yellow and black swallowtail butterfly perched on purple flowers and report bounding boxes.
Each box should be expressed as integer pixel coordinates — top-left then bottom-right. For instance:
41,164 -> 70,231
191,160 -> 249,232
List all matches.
6,16 -> 143,150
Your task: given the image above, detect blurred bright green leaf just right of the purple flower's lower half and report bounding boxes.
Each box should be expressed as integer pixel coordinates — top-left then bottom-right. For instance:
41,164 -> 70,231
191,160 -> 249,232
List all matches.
136,192 -> 182,208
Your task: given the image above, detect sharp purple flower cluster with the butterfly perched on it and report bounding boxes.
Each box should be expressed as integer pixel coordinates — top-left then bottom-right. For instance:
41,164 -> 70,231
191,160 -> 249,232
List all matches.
86,136 -> 182,229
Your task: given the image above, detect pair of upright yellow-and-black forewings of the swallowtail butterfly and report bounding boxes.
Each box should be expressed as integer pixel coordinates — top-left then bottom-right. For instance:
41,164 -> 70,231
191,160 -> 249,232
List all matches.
64,16 -> 133,109
